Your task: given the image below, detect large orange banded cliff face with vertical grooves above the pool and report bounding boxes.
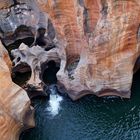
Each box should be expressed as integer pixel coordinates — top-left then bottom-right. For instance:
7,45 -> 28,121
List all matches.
37,0 -> 140,99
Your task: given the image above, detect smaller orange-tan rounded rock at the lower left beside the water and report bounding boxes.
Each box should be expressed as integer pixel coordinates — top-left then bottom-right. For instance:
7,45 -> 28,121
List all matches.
0,43 -> 35,140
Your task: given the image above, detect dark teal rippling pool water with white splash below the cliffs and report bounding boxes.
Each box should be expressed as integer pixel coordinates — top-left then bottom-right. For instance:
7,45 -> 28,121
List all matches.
21,71 -> 140,140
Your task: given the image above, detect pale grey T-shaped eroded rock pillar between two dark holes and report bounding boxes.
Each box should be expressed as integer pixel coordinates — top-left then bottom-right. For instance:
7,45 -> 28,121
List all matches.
11,43 -> 60,90
